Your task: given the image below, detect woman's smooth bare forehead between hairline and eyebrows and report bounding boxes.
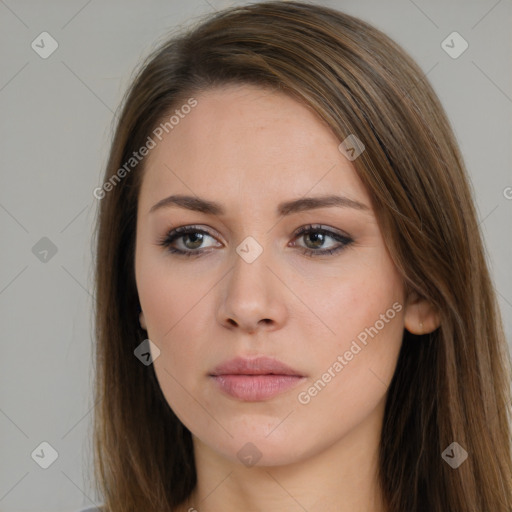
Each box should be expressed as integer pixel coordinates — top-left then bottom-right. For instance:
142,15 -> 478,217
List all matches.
139,85 -> 369,214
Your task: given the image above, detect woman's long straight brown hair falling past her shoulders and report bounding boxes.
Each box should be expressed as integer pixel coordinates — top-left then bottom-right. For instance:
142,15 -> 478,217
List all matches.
94,1 -> 512,512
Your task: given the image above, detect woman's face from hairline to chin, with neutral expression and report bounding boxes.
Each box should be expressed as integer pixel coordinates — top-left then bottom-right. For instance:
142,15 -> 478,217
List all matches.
135,85 -> 404,465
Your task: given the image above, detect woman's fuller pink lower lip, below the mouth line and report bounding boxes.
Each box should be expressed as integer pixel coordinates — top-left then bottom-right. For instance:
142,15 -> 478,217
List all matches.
212,375 -> 304,402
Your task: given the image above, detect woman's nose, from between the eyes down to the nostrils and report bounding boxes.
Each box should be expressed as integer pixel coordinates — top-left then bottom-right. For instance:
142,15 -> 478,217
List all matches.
218,245 -> 287,333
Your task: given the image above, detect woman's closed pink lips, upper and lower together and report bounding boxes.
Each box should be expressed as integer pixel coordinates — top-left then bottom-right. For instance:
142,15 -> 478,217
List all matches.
210,357 -> 305,402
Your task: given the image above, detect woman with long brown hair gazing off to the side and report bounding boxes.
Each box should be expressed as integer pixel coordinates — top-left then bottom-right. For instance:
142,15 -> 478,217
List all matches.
89,2 -> 512,512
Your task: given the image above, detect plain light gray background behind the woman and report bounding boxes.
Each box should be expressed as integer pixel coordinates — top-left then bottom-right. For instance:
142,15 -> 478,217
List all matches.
0,0 -> 512,512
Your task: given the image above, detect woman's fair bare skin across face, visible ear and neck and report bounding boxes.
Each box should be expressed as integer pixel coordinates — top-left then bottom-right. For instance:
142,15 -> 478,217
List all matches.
135,85 -> 438,512
